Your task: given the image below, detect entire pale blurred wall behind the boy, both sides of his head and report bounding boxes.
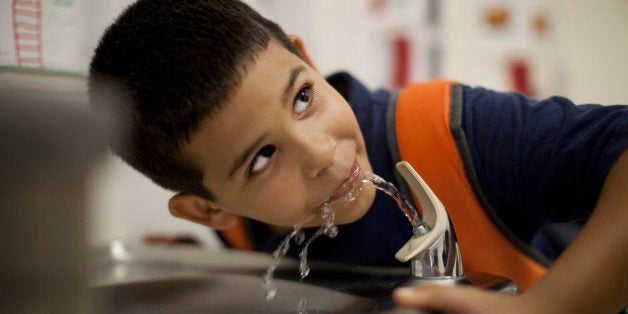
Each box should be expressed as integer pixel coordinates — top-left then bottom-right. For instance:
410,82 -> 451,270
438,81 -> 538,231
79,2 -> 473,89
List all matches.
0,0 -> 628,247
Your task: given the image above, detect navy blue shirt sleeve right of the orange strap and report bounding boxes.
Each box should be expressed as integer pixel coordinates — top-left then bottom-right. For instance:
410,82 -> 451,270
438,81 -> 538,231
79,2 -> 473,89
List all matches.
462,87 -> 628,242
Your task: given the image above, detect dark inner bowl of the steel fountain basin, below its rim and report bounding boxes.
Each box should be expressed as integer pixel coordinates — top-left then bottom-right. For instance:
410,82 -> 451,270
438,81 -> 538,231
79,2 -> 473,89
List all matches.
93,273 -> 376,313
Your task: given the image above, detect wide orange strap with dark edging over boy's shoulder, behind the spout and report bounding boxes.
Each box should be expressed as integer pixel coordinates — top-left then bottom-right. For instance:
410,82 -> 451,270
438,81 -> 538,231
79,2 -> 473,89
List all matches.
387,81 -> 549,290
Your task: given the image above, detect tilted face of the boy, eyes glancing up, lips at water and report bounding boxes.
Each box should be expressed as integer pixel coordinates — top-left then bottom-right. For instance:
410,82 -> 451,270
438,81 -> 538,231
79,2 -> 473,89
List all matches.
183,40 -> 375,227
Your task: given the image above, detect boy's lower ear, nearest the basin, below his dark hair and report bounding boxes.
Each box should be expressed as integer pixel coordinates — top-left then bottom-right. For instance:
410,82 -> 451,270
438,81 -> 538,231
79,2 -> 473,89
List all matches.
168,193 -> 238,230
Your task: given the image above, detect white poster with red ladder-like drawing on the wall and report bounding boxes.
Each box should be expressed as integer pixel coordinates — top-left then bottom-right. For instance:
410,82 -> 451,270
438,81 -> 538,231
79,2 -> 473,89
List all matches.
0,0 -> 89,73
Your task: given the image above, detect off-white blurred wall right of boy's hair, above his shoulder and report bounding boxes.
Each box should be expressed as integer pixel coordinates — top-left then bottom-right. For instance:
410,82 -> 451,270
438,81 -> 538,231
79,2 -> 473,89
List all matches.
248,0 -> 628,104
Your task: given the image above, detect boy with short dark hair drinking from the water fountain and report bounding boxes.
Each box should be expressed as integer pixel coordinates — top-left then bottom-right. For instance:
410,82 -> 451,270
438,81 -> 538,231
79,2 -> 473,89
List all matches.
90,0 -> 628,313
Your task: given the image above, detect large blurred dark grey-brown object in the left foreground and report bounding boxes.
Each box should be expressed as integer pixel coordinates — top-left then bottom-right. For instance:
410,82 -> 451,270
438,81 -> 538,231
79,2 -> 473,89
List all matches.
0,75 -> 105,313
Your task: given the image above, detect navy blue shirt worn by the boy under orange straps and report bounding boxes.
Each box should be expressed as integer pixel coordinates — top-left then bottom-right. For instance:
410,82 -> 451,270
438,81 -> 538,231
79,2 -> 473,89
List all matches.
249,73 -> 628,265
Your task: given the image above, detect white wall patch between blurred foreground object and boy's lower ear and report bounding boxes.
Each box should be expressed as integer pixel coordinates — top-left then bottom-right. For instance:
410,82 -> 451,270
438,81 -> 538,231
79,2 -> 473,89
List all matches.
88,156 -> 221,248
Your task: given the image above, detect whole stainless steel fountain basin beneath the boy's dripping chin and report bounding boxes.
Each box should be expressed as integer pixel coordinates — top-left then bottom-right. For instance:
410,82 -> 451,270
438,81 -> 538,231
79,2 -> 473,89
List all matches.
91,242 -> 409,313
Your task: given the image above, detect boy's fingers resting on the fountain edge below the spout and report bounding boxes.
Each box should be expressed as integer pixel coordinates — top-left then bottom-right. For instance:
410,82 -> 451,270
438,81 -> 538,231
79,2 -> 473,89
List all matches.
393,285 -> 499,313
